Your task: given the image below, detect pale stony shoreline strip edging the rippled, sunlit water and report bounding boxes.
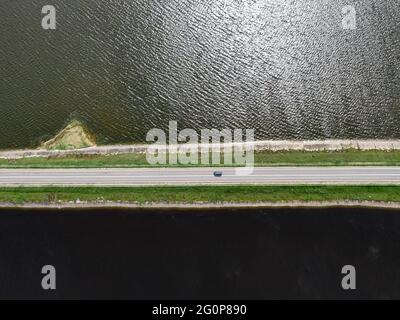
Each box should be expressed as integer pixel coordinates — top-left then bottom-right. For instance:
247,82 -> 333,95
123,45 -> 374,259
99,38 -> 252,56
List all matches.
0,139 -> 400,160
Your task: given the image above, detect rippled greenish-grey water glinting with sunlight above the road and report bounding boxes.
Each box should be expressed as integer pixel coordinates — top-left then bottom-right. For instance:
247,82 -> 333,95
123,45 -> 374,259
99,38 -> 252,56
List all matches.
0,0 -> 400,148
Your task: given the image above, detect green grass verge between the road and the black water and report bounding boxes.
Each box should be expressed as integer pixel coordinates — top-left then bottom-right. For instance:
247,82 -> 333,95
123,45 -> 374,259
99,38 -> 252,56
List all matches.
0,186 -> 400,204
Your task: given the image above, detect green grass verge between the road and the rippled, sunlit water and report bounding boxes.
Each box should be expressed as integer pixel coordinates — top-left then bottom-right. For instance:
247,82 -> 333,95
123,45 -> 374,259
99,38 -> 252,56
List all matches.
0,150 -> 400,168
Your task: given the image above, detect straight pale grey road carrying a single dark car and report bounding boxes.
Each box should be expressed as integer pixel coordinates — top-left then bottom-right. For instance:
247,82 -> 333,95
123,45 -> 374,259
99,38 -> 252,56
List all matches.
0,167 -> 400,186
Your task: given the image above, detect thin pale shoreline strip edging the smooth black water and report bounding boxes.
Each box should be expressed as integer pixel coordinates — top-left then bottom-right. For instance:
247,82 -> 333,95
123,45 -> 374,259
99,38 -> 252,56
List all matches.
0,201 -> 400,210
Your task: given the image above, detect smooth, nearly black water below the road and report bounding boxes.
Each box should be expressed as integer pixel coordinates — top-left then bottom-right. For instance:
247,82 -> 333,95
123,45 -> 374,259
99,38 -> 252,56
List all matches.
0,209 -> 400,299
